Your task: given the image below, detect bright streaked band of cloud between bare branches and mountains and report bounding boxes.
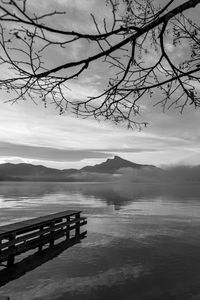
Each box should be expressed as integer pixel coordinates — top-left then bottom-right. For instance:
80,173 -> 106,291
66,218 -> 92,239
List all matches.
0,98 -> 200,168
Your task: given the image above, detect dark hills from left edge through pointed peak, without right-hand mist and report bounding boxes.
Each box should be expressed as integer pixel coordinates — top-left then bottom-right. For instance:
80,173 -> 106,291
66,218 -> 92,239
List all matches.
0,156 -> 156,181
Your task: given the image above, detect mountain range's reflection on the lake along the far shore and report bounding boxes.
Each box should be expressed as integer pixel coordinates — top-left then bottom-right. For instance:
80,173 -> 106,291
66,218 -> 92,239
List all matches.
0,182 -> 200,210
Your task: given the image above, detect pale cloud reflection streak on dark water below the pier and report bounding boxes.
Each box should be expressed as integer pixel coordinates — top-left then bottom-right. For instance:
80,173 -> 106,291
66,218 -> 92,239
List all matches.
10,265 -> 145,300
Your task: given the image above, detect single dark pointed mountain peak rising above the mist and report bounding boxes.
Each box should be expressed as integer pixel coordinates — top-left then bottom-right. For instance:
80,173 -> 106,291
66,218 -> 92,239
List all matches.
81,156 -> 156,174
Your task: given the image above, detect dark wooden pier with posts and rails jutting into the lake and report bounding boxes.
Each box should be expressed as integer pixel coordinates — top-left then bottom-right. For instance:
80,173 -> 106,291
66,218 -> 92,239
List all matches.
0,210 -> 87,267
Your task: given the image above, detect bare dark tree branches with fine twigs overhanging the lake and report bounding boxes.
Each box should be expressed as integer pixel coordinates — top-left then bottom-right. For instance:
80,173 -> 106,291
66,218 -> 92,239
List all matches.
0,0 -> 200,127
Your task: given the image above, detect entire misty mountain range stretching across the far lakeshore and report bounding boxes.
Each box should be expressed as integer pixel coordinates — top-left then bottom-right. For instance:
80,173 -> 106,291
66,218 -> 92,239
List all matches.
0,156 -> 200,183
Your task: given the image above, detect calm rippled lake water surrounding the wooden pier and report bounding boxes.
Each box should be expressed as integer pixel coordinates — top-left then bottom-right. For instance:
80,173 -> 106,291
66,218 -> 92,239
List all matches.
0,183 -> 200,300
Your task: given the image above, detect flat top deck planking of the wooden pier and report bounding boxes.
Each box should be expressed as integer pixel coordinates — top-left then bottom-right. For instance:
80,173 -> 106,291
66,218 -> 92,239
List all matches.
0,210 -> 81,238
